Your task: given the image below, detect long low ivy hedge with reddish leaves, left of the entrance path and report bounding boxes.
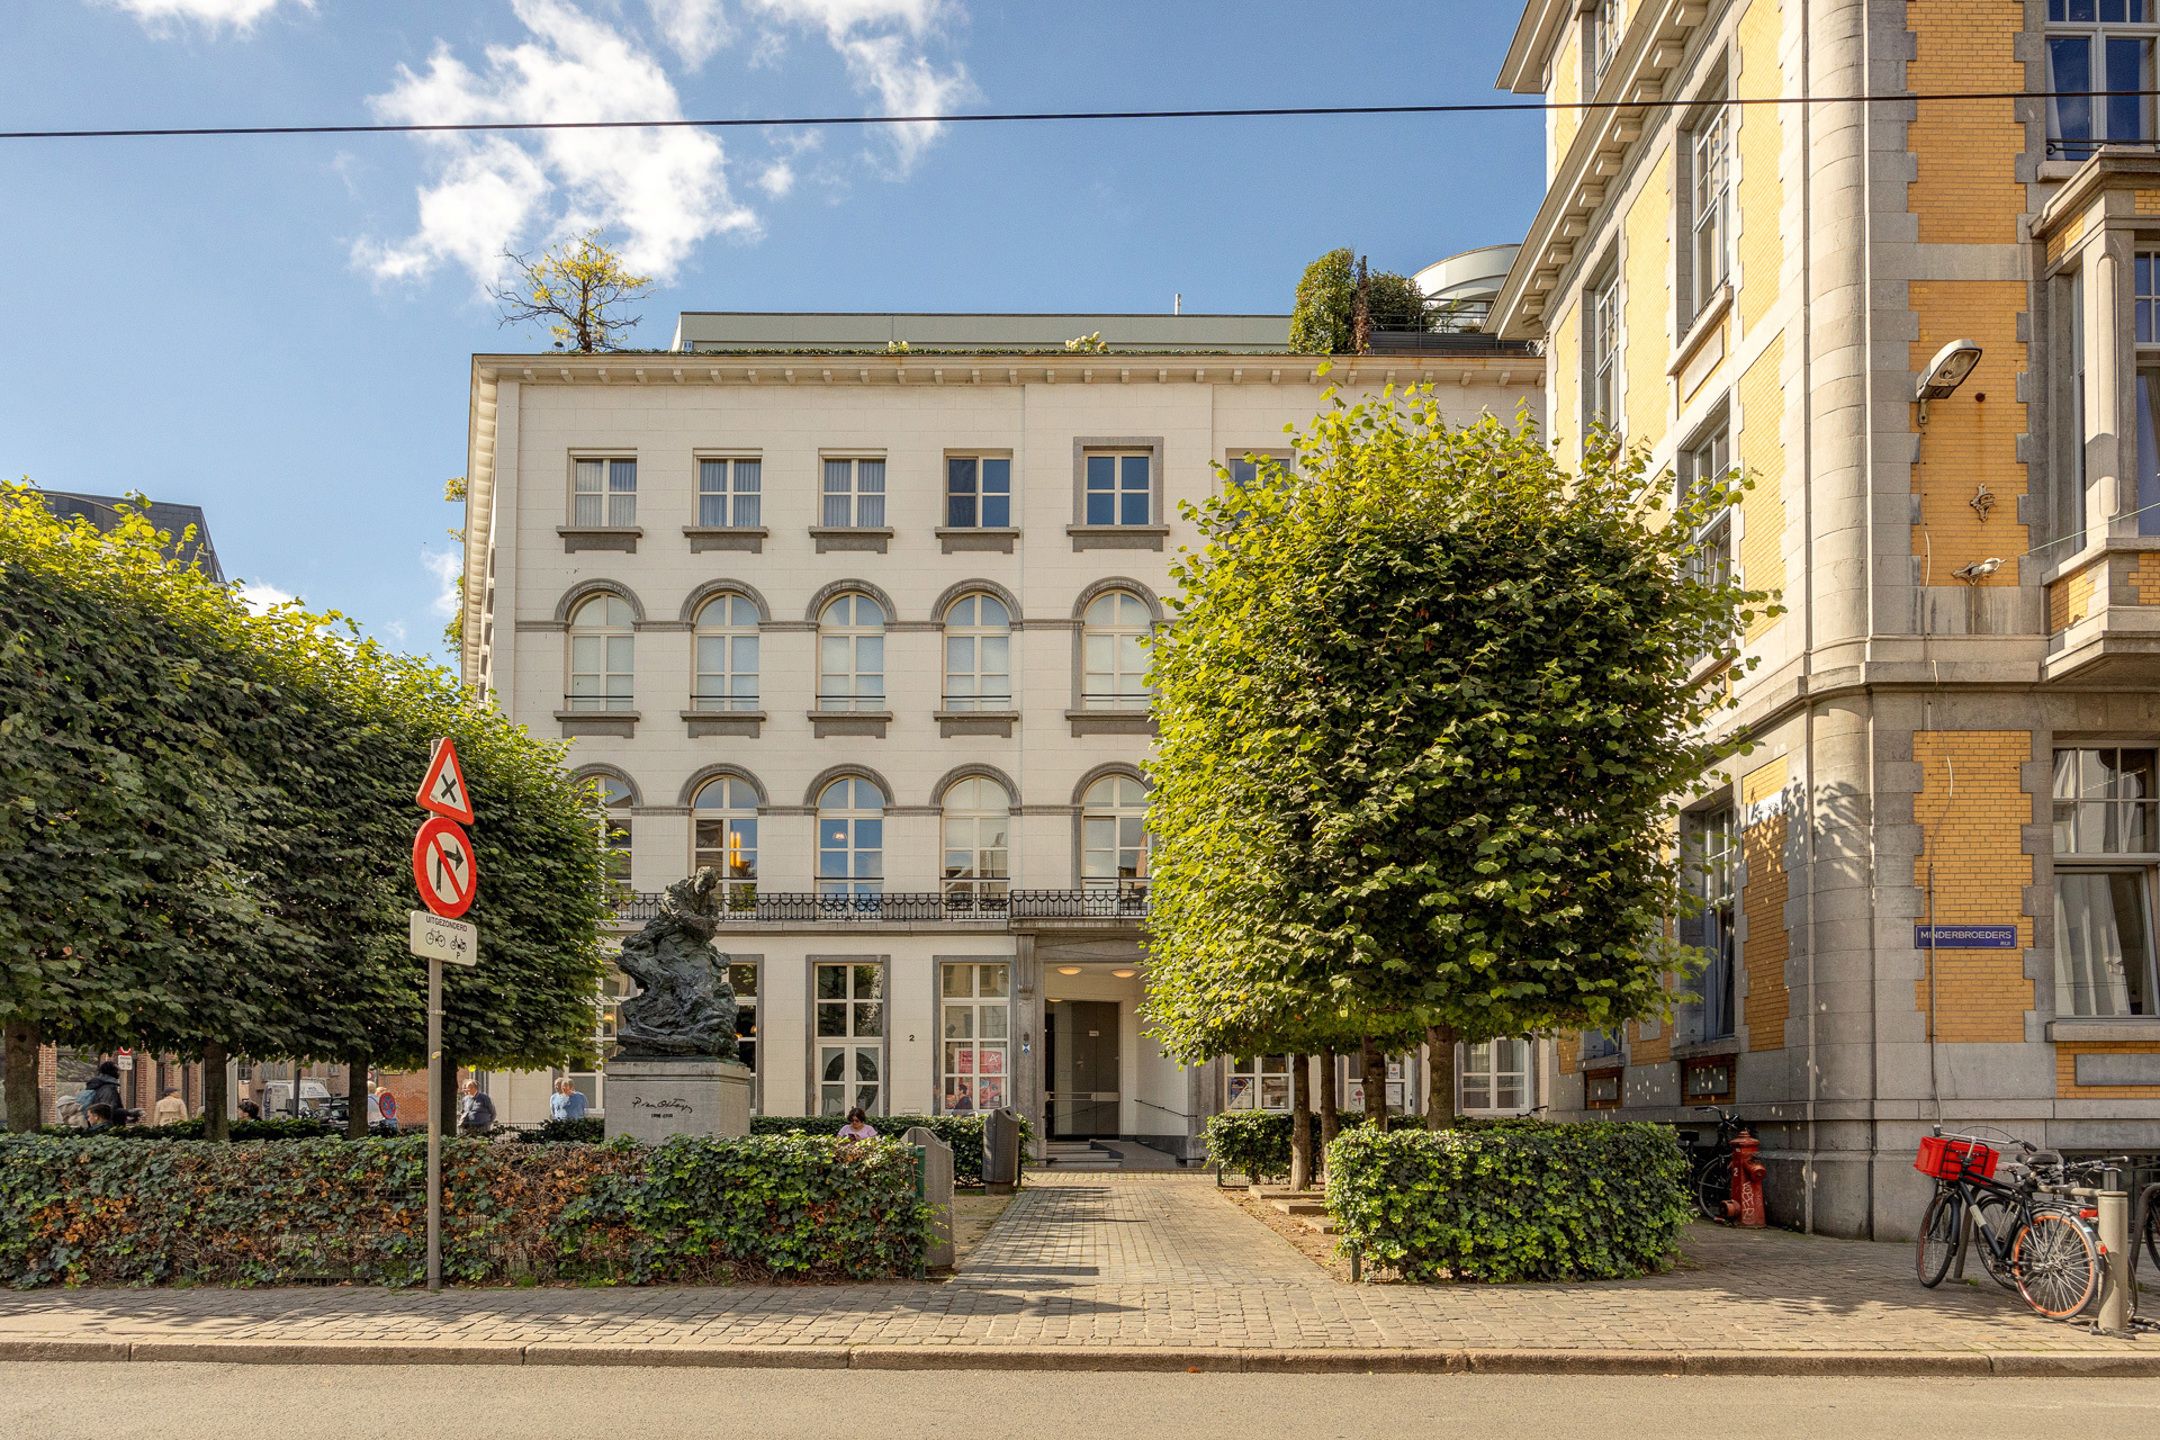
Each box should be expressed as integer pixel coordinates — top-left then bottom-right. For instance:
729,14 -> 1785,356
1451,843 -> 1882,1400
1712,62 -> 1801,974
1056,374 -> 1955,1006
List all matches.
0,1136 -> 929,1289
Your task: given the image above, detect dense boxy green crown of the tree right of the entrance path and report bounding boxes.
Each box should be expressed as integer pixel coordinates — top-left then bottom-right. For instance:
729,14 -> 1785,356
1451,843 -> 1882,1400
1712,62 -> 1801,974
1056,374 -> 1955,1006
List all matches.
1149,386 -> 1769,1123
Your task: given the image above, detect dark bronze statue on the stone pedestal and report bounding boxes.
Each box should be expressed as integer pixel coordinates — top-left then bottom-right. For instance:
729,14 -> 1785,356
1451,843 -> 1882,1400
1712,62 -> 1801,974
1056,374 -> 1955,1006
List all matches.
616,870 -> 734,1060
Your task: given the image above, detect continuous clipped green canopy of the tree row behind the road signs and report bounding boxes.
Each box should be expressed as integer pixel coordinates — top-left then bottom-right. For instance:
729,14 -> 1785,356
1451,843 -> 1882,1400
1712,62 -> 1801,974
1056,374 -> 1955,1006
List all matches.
0,486 -> 605,1122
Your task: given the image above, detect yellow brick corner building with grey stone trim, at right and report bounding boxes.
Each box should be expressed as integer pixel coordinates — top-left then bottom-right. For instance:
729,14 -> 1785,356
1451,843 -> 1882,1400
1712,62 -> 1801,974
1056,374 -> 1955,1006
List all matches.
1495,0 -> 2160,1237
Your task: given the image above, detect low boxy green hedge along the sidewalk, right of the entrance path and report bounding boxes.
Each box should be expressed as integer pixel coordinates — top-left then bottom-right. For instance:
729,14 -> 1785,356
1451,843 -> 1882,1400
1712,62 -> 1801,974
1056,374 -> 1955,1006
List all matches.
1328,1120 -> 1691,1280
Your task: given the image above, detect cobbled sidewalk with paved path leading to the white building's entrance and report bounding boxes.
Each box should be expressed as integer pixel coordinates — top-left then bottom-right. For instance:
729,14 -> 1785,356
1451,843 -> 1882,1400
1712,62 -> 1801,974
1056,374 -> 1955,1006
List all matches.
0,1174 -> 2160,1375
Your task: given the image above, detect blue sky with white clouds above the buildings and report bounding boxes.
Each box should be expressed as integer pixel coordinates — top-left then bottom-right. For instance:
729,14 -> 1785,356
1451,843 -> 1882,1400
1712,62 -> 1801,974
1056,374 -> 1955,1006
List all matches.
0,0 -> 1542,654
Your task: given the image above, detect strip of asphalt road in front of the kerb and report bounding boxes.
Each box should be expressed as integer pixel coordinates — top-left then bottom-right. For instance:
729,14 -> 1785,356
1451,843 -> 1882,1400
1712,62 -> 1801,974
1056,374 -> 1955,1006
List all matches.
0,1362 -> 2160,1440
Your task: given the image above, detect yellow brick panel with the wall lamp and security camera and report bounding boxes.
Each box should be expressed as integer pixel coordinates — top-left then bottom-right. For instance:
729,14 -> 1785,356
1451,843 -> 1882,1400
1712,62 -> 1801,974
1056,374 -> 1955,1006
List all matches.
1907,284 -> 2033,585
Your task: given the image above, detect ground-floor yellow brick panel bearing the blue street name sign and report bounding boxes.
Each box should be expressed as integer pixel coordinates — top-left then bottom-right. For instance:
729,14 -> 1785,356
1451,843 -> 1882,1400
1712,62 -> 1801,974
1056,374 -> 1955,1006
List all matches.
1912,730 -> 2033,1045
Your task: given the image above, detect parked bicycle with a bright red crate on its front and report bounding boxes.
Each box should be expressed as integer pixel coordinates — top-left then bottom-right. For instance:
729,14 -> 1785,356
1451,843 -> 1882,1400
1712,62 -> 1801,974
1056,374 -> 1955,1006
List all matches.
1914,1125 -> 2100,1319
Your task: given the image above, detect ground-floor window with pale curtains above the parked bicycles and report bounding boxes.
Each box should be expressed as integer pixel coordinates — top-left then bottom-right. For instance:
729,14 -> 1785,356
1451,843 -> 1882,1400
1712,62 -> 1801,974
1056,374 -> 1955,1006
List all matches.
2054,745 -> 2160,1017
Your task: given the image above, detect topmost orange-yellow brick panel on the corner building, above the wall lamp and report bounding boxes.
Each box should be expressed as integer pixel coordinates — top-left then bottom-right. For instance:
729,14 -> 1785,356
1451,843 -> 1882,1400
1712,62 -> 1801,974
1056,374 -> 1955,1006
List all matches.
1905,0 -> 2026,246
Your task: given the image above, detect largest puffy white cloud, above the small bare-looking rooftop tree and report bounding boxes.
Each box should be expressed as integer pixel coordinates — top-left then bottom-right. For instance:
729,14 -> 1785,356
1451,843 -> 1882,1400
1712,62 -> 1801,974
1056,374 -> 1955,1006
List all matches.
352,0 -> 756,283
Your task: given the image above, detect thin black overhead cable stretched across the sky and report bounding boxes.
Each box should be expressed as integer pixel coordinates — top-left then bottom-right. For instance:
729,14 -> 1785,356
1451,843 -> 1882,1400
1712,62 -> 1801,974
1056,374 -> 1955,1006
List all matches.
0,91 -> 2160,140
